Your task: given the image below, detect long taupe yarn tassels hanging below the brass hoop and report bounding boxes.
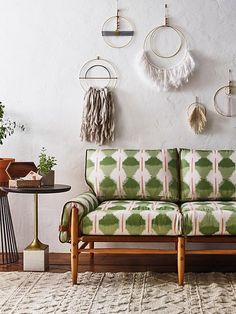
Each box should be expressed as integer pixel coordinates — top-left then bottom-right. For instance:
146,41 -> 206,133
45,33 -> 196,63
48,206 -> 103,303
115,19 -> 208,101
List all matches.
80,87 -> 115,145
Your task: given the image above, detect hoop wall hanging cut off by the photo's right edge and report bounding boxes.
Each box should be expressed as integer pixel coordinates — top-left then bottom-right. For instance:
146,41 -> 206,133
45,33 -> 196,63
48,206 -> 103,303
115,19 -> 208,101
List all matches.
214,69 -> 236,117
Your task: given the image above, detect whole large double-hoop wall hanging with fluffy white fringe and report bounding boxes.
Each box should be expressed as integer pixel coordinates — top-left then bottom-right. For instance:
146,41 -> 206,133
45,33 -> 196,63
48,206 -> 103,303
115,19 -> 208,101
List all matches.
139,5 -> 195,91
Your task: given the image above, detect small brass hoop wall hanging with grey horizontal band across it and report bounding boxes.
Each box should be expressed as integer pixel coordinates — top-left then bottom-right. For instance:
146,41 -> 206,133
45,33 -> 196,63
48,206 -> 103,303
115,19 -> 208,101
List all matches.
102,0 -> 134,48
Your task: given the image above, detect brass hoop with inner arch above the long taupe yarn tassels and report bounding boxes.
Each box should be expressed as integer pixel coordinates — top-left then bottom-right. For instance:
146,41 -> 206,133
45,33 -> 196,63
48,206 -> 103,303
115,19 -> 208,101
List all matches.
79,56 -> 118,91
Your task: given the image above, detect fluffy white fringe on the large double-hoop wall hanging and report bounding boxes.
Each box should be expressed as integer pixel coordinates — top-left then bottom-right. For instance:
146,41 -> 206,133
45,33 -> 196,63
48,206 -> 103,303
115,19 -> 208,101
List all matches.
140,50 -> 195,92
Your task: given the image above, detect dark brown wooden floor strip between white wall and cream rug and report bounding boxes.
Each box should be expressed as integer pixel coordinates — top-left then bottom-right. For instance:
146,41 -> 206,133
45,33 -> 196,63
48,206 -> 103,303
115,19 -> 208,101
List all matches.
0,253 -> 236,272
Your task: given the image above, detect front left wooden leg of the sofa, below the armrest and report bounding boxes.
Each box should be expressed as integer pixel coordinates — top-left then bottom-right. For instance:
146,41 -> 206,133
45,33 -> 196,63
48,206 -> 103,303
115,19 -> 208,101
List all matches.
71,207 -> 79,285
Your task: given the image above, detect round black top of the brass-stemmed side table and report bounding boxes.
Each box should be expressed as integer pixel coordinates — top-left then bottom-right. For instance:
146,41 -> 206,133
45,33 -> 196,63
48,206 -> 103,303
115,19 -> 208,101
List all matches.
1,184 -> 71,194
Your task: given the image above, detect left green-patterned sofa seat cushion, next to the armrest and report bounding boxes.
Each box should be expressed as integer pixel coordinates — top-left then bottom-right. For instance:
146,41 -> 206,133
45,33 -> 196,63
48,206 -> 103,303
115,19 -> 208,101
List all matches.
81,200 -> 181,235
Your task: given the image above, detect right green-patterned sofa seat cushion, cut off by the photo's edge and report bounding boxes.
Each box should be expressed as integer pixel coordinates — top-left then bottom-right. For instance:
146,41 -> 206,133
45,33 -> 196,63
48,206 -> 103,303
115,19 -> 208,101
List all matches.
181,201 -> 236,236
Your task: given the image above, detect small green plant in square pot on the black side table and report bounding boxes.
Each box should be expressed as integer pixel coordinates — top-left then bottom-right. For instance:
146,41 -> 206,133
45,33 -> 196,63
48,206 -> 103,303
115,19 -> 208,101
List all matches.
37,147 -> 57,186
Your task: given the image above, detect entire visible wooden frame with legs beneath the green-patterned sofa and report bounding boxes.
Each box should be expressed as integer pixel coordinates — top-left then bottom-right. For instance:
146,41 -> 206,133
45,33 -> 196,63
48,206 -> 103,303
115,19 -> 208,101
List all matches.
71,207 -> 236,286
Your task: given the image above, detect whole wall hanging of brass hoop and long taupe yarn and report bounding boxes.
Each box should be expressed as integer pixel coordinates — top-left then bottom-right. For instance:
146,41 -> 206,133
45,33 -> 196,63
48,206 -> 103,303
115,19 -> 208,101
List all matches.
79,57 -> 117,145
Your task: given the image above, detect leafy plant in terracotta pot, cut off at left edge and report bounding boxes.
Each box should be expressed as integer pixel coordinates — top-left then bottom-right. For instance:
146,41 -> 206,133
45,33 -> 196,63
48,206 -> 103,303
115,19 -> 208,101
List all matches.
0,102 -> 25,186
